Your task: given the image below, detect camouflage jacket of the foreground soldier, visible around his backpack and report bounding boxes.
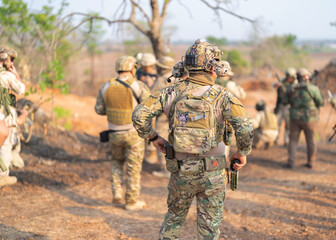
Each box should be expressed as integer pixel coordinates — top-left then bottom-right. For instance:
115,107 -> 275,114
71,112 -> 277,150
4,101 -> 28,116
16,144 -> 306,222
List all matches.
132,79 -> 253,155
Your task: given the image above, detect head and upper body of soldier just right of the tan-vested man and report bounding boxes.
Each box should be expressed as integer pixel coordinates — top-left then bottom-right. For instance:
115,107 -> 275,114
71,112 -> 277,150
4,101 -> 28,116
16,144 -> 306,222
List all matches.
136,53 -> 157,89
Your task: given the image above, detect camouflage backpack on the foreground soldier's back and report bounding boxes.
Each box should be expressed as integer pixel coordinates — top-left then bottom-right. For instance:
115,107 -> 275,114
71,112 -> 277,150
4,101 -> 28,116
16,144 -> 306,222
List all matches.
169,84 -> 224,154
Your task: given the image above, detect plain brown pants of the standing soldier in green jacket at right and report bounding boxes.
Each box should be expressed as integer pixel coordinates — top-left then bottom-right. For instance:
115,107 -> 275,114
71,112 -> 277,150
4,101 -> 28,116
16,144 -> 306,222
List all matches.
288,120 -> 317,166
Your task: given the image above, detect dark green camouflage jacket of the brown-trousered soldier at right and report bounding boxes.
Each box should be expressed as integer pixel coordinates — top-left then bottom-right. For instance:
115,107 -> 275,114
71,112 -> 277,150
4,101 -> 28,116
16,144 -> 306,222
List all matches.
283,81 -> 324,122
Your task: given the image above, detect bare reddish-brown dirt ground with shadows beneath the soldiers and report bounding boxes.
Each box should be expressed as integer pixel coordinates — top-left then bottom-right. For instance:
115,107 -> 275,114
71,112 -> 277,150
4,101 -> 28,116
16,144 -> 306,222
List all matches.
0,124 -> 336,240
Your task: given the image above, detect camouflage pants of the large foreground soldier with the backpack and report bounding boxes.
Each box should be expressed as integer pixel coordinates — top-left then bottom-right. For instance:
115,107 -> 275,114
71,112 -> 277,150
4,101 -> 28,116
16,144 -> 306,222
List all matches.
160,170 -> 227,240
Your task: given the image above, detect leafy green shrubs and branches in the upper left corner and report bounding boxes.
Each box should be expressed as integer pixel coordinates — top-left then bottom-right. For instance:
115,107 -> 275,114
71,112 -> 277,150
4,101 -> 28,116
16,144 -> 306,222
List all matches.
0,0 -> 76,93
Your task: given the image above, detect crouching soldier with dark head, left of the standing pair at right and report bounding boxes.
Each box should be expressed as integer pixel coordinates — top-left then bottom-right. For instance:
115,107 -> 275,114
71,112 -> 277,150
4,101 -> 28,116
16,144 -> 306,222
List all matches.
251,100 -> 278,149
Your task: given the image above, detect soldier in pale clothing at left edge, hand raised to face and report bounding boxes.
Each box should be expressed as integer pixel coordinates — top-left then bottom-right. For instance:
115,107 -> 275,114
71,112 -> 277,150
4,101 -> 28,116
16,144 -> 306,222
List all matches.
0,47 -> 28,187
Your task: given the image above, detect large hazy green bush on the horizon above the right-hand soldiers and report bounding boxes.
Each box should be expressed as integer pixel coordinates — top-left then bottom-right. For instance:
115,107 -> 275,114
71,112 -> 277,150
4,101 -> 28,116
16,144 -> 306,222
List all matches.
251,34 -> 307,70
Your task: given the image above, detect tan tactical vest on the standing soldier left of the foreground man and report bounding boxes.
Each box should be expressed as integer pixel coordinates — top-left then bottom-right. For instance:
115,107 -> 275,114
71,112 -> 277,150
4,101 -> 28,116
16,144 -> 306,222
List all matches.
104,78 -> 136,125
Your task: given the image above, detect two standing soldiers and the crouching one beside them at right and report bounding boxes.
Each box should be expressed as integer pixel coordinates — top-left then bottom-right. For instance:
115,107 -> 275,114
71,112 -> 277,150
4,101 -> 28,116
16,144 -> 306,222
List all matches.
252,68 -> 324,169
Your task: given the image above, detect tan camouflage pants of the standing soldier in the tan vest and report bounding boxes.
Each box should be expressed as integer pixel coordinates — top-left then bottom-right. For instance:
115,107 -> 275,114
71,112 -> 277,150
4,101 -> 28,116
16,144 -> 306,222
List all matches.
109,131 -> 145,204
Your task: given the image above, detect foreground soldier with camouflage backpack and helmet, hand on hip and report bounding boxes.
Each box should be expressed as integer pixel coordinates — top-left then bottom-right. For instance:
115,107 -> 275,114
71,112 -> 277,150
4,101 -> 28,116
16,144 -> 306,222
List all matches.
132,40 -> 253,240
